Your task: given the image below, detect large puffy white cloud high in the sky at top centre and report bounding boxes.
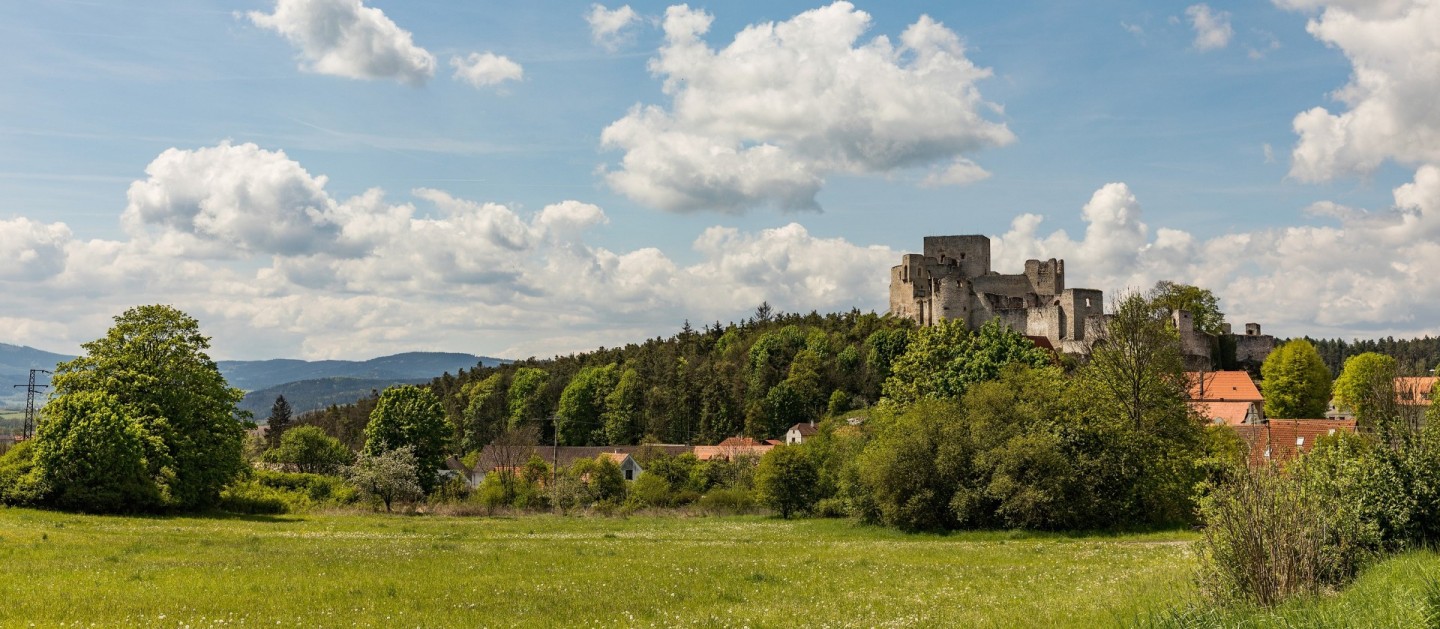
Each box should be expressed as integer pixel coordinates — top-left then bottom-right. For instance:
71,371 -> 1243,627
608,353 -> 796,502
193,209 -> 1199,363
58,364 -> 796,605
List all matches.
600,1 -> 1014,213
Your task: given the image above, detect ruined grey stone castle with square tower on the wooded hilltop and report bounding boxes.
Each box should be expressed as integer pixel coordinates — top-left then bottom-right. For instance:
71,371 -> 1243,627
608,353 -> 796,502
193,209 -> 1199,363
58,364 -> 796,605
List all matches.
890,236 -> 1104,354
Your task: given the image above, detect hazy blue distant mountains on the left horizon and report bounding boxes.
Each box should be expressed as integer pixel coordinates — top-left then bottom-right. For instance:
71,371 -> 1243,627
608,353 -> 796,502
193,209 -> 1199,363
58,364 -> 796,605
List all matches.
0,343 -> 505,420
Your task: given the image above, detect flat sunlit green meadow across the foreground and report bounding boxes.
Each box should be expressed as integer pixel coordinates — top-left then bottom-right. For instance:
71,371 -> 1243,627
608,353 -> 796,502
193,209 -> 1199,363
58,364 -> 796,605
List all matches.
0,510 -> 1192,626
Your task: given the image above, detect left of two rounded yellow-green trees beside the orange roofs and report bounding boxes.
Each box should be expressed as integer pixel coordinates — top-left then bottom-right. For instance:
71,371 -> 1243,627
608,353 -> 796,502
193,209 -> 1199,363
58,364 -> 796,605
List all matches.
1260,338 -> 1331,419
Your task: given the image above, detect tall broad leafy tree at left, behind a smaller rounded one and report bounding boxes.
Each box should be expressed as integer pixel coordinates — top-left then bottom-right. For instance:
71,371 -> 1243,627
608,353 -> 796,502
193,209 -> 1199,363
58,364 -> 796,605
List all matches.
36,305 -> 246,510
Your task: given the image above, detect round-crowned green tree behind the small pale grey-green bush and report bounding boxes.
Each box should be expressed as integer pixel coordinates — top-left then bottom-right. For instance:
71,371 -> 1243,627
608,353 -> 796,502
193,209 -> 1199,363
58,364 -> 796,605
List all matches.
364,384 -> 451,491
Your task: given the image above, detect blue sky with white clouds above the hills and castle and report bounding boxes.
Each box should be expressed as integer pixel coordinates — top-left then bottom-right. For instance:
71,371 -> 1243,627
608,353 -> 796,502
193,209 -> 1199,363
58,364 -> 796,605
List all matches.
0,0 -> 1440,360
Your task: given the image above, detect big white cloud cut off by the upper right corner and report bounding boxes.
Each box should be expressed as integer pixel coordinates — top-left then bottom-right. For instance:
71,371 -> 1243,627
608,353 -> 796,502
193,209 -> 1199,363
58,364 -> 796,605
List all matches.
1279,0 -> 1440,181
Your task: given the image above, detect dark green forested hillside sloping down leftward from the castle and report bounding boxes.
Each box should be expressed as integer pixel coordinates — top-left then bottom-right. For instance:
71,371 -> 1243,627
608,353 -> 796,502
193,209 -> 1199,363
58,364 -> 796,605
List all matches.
301,307 -> 912,451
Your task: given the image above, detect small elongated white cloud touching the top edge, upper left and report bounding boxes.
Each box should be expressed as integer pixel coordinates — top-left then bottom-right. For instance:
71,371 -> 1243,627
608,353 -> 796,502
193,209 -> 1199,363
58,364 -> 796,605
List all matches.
246,0 -> 435,85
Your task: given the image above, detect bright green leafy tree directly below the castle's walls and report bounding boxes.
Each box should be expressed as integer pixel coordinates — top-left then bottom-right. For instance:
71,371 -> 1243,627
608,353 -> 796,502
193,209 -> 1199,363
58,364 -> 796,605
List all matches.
884,320 -> 1051,404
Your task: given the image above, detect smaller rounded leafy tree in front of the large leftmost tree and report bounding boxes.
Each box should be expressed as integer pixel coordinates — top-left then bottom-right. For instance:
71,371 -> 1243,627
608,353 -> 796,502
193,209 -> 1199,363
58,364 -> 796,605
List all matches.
35,392 -> 161,511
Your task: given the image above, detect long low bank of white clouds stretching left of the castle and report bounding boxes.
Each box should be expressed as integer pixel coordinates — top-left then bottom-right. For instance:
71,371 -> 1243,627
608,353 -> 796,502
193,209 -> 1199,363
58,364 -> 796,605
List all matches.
0,142 -> 896,358
